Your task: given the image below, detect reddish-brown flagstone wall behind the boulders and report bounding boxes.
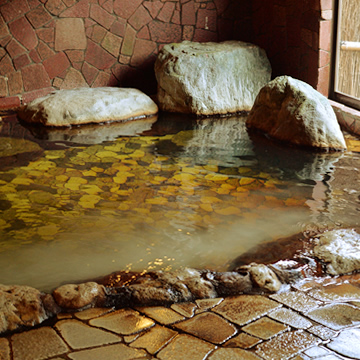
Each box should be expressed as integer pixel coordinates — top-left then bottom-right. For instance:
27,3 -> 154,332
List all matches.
0,0 -> 332,109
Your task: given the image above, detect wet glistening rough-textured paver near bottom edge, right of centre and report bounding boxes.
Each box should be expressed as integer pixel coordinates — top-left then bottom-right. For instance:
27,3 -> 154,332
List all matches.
255,330 -> 320,360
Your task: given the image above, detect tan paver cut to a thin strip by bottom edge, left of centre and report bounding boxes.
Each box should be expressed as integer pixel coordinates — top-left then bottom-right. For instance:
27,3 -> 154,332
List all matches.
68,344 -> 146,360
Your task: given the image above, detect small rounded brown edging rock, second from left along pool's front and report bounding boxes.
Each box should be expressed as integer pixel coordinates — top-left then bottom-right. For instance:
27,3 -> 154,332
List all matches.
52,282 -> 105,310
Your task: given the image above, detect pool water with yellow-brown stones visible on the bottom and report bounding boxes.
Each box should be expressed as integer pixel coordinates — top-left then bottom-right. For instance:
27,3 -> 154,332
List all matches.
0,111 -> 360,291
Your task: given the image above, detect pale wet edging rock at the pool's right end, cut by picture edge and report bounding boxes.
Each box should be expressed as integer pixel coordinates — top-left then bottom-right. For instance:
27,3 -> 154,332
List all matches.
313,229 -> 360,275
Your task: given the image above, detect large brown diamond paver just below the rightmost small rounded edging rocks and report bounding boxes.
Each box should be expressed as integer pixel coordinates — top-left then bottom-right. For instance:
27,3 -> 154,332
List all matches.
212,295 -> 282,326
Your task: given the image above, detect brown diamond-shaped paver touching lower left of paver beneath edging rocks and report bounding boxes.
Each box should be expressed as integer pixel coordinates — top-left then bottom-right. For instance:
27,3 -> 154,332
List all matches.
175,312 -> 237,344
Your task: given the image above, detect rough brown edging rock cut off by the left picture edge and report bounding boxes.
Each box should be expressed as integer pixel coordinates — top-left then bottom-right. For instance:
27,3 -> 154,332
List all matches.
0,285 -> 59,333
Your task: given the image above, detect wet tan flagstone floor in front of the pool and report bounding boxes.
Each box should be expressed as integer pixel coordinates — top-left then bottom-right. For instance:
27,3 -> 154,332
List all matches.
0,274 -> 360,360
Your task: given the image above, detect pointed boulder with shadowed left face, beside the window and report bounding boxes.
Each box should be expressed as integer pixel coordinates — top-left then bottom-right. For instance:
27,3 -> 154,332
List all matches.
246,76 -> 346,150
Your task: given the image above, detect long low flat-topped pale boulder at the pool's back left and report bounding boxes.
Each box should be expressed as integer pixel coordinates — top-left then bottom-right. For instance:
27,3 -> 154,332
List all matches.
18,87 -> 158,126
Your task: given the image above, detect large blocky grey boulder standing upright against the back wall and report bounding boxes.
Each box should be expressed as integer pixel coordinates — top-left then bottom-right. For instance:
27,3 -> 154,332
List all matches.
155,41 -> 271,116
